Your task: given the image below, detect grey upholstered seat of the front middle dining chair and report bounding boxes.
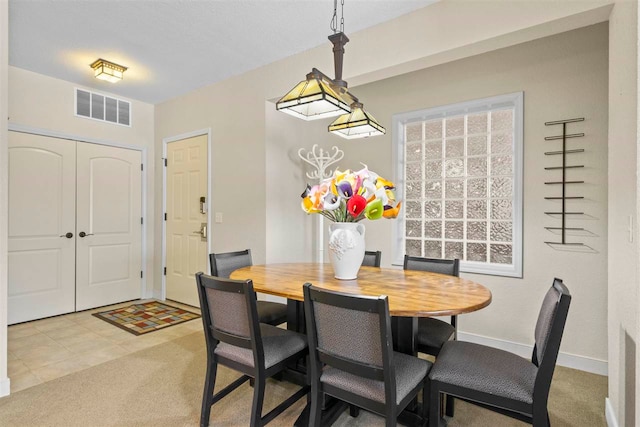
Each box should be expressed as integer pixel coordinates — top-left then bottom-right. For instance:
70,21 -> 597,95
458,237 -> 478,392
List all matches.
320,352 -> 431,404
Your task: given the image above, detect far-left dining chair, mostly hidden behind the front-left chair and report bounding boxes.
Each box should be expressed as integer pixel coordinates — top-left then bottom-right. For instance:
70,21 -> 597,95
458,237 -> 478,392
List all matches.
209,249 -> 287,326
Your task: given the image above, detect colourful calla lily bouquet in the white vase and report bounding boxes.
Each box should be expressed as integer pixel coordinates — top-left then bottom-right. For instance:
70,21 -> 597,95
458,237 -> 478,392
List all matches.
302,165 -> 401,222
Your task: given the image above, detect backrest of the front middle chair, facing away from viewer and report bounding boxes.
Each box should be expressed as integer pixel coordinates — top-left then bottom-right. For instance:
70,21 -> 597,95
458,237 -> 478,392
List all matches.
304,283 -> 396,402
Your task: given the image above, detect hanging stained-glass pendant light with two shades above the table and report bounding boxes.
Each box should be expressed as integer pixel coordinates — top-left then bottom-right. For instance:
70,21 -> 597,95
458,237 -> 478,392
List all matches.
276,0 -> 385,139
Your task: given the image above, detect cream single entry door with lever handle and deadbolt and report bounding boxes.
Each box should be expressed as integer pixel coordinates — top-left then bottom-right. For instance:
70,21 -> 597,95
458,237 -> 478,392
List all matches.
165,135 -> 208,307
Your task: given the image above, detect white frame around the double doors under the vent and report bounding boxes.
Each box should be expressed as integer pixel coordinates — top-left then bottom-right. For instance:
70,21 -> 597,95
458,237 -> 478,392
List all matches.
8,123 -> 153,299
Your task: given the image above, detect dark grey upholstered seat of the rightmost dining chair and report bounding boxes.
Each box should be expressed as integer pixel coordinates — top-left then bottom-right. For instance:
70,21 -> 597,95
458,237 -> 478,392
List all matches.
429,341 -> 538,405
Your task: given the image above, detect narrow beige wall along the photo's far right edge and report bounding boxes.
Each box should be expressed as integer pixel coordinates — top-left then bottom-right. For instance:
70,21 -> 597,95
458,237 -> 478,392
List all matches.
608,1 -> 640,426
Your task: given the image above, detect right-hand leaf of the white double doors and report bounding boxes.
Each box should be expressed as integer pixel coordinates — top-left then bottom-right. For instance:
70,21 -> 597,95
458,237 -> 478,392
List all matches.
76,144 -> 142,310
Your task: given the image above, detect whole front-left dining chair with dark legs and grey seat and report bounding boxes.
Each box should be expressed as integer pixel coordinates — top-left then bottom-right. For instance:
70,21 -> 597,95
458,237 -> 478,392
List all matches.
196,273 -> 309,427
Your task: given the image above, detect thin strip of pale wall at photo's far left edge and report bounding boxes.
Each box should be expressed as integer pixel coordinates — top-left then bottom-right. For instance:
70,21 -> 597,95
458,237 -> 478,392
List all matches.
0,1 -> 9,396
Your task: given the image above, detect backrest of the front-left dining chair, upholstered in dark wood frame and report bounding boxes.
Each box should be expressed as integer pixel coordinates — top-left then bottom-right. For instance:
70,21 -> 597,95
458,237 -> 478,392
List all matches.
196,272 -> 264,366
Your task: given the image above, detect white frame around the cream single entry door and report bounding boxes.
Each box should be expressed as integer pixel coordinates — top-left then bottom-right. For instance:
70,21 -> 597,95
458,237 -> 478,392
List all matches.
158,128 -> 213,301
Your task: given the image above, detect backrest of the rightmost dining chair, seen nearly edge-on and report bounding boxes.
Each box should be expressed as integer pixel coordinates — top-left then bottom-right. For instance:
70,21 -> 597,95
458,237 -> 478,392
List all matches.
531,279 -> 571,407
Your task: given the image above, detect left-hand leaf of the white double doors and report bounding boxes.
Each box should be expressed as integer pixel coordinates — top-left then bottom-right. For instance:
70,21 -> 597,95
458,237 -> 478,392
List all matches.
8,132 -> 76,324
